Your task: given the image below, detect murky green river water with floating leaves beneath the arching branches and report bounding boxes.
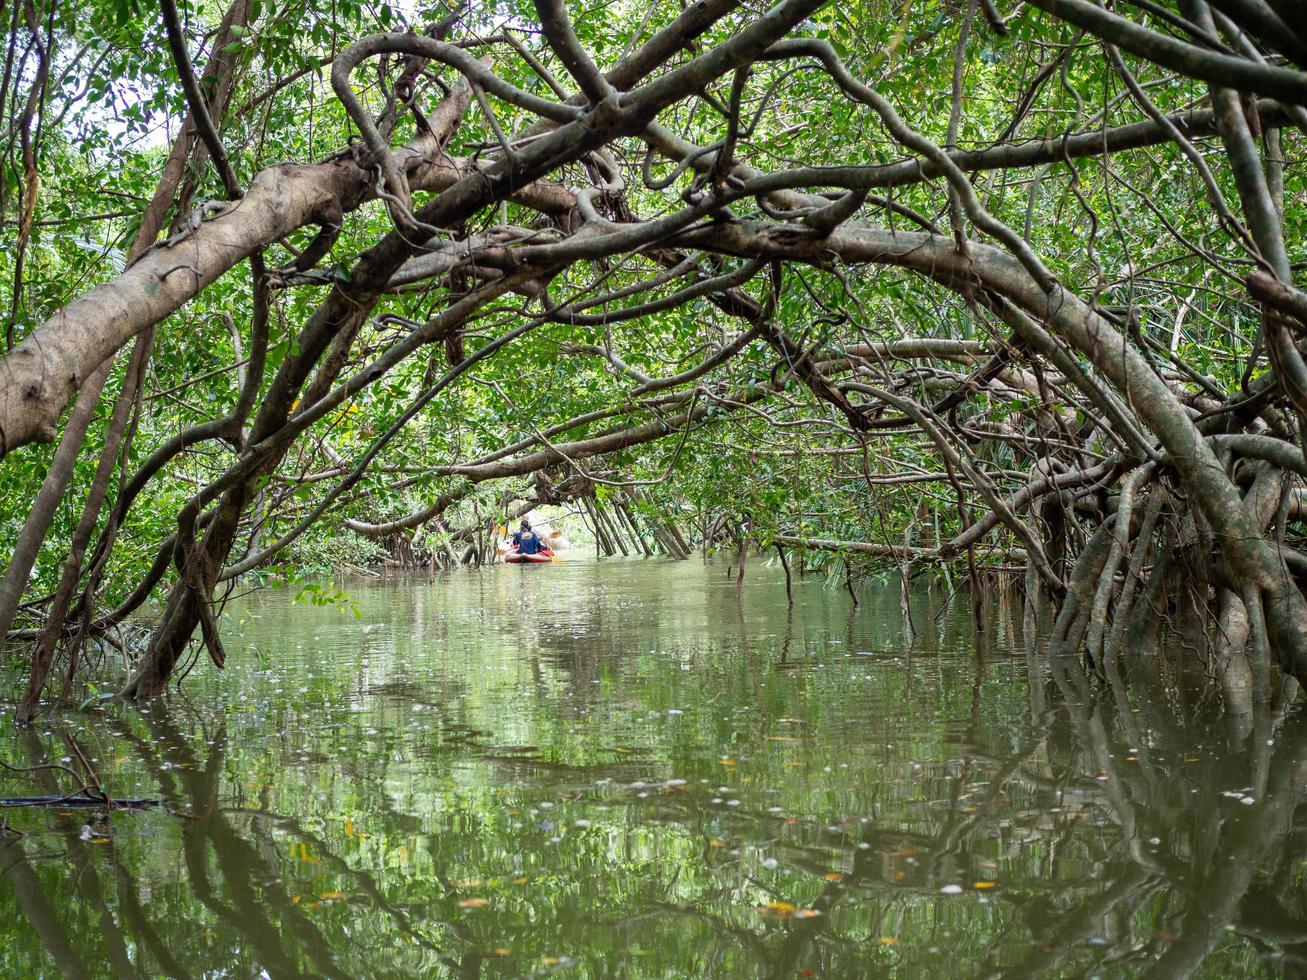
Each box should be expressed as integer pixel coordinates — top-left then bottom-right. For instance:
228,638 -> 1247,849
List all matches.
0,561 -> 1307,977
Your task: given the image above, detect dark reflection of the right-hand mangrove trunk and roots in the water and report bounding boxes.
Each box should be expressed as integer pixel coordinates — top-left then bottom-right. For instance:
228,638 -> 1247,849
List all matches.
988,660 -> 1307,977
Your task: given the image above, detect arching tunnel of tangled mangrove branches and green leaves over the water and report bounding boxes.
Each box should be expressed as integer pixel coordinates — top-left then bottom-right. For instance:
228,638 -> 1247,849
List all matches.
0,0 -> 1307,717
